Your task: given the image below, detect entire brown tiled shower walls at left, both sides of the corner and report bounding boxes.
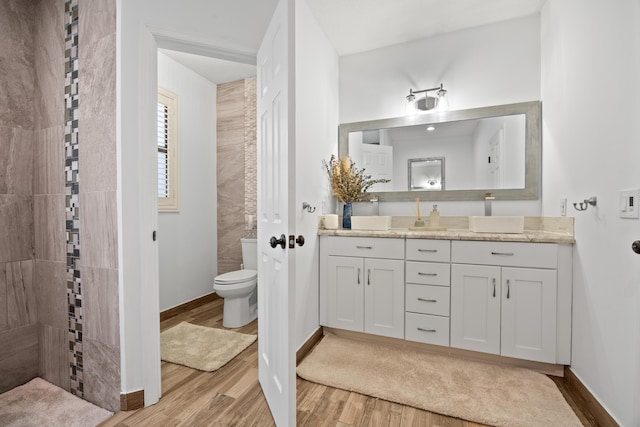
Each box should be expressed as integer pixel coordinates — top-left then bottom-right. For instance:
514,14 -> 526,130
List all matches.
0,0 -> 120,410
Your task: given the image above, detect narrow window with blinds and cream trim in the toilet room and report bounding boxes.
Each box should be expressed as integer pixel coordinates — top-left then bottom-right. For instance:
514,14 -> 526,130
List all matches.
156,88 -> 180,212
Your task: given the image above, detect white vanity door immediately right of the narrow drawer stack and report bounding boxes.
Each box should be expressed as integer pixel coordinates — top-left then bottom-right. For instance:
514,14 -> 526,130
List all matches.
451,264 -> 500,354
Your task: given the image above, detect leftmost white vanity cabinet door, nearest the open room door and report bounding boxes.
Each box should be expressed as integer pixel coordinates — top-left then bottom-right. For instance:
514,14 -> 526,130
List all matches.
327,256 -> 364,332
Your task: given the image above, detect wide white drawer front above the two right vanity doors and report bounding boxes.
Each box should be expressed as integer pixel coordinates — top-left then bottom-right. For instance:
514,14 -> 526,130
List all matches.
451,241 -> 558,268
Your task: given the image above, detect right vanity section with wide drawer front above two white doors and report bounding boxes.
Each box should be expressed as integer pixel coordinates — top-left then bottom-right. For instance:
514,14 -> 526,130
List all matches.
450,241 -> 558,363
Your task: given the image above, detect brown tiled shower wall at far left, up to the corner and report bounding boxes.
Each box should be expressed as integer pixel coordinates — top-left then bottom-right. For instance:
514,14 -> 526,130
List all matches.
0,0 -> 38,393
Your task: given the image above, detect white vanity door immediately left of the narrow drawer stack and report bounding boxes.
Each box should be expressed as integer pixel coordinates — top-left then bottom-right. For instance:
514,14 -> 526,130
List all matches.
364,258 -> 404,338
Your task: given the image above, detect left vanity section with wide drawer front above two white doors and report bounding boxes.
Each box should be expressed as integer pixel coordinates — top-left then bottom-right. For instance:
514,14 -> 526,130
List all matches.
320,236 -> 404,338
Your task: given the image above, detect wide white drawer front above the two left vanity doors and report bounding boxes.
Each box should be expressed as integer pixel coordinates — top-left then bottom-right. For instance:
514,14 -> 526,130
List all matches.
327,236 -> 404,259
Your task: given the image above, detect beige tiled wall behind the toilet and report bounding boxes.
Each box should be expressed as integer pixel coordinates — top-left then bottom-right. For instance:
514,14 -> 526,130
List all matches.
216,78 -> 257,274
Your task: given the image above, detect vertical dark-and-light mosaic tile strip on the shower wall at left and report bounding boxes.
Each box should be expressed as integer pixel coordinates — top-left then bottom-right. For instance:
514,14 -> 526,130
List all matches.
64,0 -> 84,397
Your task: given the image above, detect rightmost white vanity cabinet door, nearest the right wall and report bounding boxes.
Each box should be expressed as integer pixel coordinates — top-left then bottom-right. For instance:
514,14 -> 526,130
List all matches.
500,267 -> 557,363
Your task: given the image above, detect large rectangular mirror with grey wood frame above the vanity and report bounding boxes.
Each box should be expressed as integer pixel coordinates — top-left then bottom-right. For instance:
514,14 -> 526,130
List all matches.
338,101 -> 542,201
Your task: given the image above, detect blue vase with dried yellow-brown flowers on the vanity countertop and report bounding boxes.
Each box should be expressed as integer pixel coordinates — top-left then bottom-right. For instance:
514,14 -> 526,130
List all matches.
323,154 -> 389,229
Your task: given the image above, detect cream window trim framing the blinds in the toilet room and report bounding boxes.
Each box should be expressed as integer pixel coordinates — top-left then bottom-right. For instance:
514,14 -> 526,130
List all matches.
155,87 -> 180,212
